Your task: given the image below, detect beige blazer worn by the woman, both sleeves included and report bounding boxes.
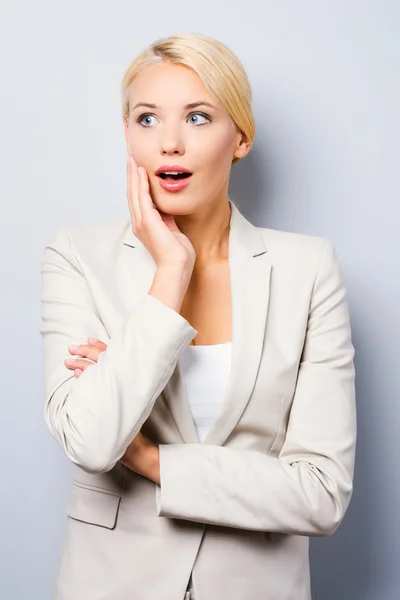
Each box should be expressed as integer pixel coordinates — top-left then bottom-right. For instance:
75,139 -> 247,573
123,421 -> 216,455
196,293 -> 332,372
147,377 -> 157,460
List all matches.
41,201 -> 356,600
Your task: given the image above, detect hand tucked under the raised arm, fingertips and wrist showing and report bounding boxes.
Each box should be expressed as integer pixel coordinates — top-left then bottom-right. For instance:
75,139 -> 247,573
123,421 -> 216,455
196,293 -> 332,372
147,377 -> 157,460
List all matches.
64,337 -> 160,483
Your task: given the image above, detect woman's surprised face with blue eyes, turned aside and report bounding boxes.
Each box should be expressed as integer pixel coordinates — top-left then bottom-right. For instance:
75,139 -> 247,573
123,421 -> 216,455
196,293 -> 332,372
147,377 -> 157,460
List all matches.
125,63 -> 250,215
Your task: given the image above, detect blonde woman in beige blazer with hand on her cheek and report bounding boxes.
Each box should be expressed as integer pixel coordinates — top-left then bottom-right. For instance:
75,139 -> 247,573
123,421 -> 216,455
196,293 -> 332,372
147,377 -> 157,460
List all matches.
42,34 -> 356,600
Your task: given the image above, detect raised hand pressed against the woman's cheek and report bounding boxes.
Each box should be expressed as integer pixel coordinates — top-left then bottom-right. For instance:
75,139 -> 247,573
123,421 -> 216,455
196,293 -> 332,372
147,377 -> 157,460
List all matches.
127,154 -> 196,270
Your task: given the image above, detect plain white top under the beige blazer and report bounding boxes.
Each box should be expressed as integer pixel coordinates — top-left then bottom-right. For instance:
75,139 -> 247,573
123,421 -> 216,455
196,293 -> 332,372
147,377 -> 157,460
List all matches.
179,342 -> 232,442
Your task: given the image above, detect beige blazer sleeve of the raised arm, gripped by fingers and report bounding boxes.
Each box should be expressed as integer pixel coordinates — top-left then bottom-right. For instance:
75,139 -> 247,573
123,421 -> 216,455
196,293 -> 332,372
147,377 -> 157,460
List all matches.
40,229 -> 197,473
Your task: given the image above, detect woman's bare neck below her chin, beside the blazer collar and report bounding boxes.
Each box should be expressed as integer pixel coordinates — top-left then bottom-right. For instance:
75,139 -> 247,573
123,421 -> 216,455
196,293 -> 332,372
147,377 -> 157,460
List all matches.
175,198 -> 231,265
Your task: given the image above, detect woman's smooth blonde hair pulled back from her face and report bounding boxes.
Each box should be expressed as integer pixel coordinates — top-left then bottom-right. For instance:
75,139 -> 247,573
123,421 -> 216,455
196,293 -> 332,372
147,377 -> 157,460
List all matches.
122,33 -> 256,165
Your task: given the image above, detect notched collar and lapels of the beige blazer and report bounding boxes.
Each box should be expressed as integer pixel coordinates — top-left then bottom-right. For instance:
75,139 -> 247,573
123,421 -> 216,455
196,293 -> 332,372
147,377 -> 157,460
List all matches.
123,200 -> 272,445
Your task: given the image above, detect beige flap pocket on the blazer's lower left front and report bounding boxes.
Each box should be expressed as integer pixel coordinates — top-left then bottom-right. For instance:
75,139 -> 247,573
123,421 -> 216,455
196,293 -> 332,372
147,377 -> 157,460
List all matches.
67,482 -> 121,529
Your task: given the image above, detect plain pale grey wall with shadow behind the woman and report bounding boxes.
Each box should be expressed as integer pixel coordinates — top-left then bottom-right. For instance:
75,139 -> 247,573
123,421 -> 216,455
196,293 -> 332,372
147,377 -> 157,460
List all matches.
0,0 -> 400,600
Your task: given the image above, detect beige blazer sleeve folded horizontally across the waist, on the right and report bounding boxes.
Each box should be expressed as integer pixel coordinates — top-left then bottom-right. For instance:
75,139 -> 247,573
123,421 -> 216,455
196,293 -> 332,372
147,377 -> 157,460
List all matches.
156,240 -> 356,536
